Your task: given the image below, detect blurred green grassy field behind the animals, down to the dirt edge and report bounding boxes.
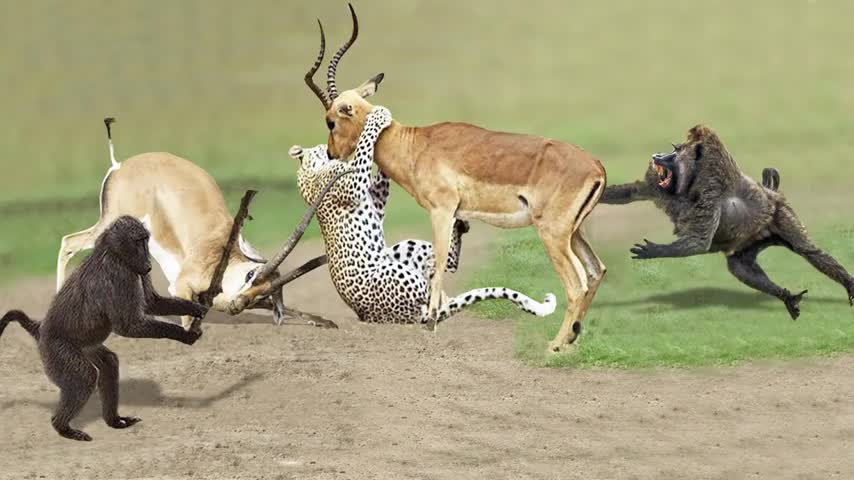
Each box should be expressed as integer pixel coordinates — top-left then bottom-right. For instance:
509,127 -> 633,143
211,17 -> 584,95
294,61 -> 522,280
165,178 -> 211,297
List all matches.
0,0 -> 854,366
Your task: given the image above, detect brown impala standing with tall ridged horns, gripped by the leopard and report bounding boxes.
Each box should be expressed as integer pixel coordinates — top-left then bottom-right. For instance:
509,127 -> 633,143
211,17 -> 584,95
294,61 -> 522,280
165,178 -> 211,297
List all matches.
305,6 -> 605,351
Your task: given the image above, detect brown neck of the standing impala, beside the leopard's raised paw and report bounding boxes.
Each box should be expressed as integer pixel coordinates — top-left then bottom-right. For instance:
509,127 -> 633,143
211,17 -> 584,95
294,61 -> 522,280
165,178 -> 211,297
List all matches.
374,121 -> 418,196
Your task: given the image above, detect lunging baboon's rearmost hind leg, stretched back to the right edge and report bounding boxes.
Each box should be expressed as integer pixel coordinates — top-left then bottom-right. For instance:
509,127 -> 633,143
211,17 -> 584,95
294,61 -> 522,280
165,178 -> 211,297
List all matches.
774,205 -> 854,305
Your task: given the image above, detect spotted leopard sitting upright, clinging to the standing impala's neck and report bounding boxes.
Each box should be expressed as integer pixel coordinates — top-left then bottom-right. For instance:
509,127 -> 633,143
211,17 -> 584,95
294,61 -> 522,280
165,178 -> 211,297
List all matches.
288,106 -> 556,324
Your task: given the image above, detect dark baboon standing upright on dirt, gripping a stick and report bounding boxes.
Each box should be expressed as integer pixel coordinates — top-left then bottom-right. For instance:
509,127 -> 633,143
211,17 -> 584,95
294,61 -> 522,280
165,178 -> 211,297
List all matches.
0,216 -> 207,441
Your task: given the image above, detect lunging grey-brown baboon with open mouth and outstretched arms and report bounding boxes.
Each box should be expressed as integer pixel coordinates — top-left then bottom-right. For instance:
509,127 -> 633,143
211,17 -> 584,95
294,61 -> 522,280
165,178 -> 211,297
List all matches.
602,125 -> 854,320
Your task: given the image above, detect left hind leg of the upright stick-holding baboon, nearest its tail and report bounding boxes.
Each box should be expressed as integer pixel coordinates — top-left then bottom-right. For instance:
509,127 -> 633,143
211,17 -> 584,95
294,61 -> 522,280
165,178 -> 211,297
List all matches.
39,340 -> 98,442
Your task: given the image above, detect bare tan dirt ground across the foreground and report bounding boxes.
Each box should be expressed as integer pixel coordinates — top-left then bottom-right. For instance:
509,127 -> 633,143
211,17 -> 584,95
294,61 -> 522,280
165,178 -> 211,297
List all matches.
0,212 -> 854,480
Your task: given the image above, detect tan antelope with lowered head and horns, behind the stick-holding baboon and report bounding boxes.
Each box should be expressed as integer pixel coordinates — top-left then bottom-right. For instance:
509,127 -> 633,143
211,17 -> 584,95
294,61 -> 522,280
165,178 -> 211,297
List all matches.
56,118 -> 336,329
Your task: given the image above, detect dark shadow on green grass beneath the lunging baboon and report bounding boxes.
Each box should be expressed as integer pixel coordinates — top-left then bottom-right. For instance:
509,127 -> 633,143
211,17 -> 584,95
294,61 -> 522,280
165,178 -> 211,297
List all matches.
597,287 -> 847,311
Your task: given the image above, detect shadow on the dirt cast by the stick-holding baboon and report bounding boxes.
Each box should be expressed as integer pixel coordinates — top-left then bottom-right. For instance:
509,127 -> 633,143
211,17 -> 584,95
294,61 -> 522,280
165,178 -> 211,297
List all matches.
0,374 -> 263,426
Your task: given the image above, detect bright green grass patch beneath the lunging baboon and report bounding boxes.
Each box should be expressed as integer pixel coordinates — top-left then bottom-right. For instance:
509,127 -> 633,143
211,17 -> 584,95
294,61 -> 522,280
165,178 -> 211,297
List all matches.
468,227 -> 854,367
